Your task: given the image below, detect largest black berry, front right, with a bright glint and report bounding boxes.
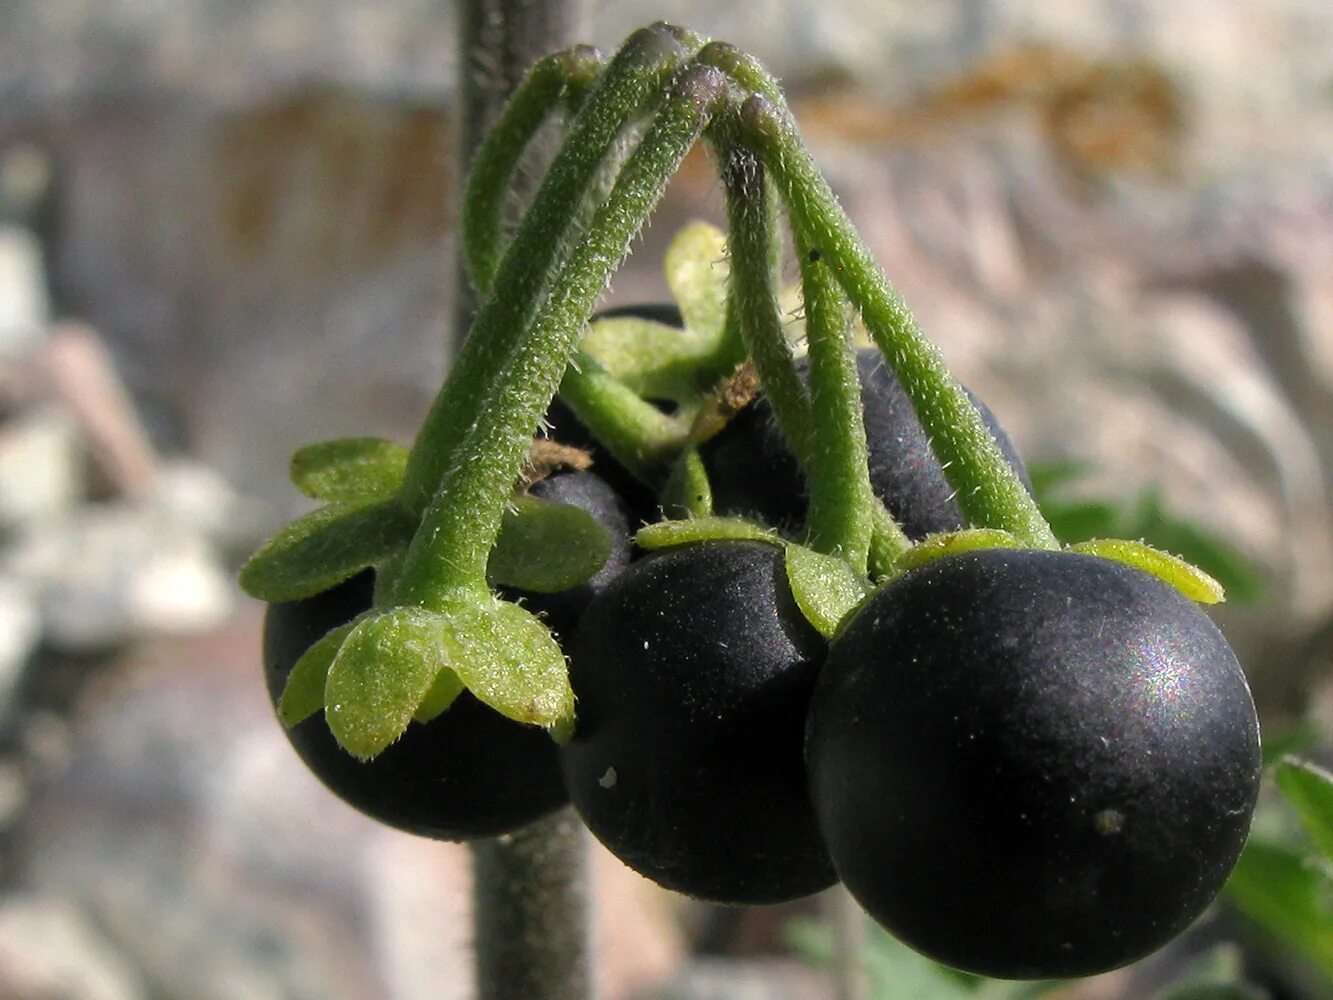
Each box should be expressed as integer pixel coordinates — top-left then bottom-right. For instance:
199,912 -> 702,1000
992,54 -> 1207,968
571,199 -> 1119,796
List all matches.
806,549 -> 1260,979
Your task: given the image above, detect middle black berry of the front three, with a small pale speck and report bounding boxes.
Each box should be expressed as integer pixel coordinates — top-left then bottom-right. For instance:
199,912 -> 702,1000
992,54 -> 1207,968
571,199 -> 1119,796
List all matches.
560,541 -> 834,903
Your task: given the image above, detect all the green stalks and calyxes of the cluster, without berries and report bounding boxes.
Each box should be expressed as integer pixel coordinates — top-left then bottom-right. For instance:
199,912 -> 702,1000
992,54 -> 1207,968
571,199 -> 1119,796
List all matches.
240,24 -> 1221,759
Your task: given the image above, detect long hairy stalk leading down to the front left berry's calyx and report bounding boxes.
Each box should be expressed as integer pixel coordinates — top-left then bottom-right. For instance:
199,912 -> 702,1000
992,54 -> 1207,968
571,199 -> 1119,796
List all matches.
396,67 -> 726,608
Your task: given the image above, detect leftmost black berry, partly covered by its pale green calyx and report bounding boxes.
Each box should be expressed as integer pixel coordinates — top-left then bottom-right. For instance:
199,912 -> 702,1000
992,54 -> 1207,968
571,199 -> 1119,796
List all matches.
264,571 -> 568,840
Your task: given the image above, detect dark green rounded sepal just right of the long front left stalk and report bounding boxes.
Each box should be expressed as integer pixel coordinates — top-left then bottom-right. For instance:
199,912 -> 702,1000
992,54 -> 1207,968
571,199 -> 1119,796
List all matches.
487,496 -> 611,593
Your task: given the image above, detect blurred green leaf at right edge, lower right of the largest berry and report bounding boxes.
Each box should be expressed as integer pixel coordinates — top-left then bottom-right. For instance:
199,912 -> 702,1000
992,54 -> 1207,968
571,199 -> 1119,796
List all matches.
1225,837 -> 1333,981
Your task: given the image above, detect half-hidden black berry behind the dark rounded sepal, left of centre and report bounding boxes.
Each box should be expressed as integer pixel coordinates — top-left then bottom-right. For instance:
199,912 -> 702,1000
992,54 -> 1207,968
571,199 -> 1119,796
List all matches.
501,472 -> 633,643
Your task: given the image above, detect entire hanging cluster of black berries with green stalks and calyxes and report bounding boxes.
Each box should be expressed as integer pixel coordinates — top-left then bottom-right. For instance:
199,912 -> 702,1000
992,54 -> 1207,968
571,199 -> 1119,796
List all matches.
243,25 -> 1260,977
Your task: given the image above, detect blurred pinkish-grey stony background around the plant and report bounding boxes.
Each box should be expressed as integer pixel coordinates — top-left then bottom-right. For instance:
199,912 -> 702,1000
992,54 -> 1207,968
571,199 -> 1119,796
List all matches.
0,0 -> 1333,1000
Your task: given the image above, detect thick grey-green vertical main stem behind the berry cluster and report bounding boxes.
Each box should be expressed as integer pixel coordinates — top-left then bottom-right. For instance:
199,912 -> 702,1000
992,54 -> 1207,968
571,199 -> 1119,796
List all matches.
455,0 -> 592,1000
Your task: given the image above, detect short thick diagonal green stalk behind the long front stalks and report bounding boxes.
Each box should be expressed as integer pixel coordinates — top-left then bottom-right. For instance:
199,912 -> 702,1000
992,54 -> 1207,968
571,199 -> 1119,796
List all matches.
560,352 -> 689,485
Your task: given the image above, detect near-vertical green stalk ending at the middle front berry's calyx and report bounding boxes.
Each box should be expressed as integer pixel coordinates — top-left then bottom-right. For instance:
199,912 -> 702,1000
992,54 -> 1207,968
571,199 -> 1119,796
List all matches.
796,230 -> 874,576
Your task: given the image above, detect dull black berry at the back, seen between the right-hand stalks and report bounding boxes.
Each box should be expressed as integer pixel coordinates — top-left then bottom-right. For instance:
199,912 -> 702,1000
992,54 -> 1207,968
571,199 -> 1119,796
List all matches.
700,348 -> 1026,540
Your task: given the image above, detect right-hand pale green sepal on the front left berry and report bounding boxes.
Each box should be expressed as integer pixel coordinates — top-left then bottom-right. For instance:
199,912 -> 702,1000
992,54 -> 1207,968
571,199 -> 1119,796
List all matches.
447,597 -> 575,729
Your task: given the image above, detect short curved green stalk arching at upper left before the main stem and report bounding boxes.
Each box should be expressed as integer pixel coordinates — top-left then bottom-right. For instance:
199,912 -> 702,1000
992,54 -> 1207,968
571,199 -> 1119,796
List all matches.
461,45 -> 603,295
